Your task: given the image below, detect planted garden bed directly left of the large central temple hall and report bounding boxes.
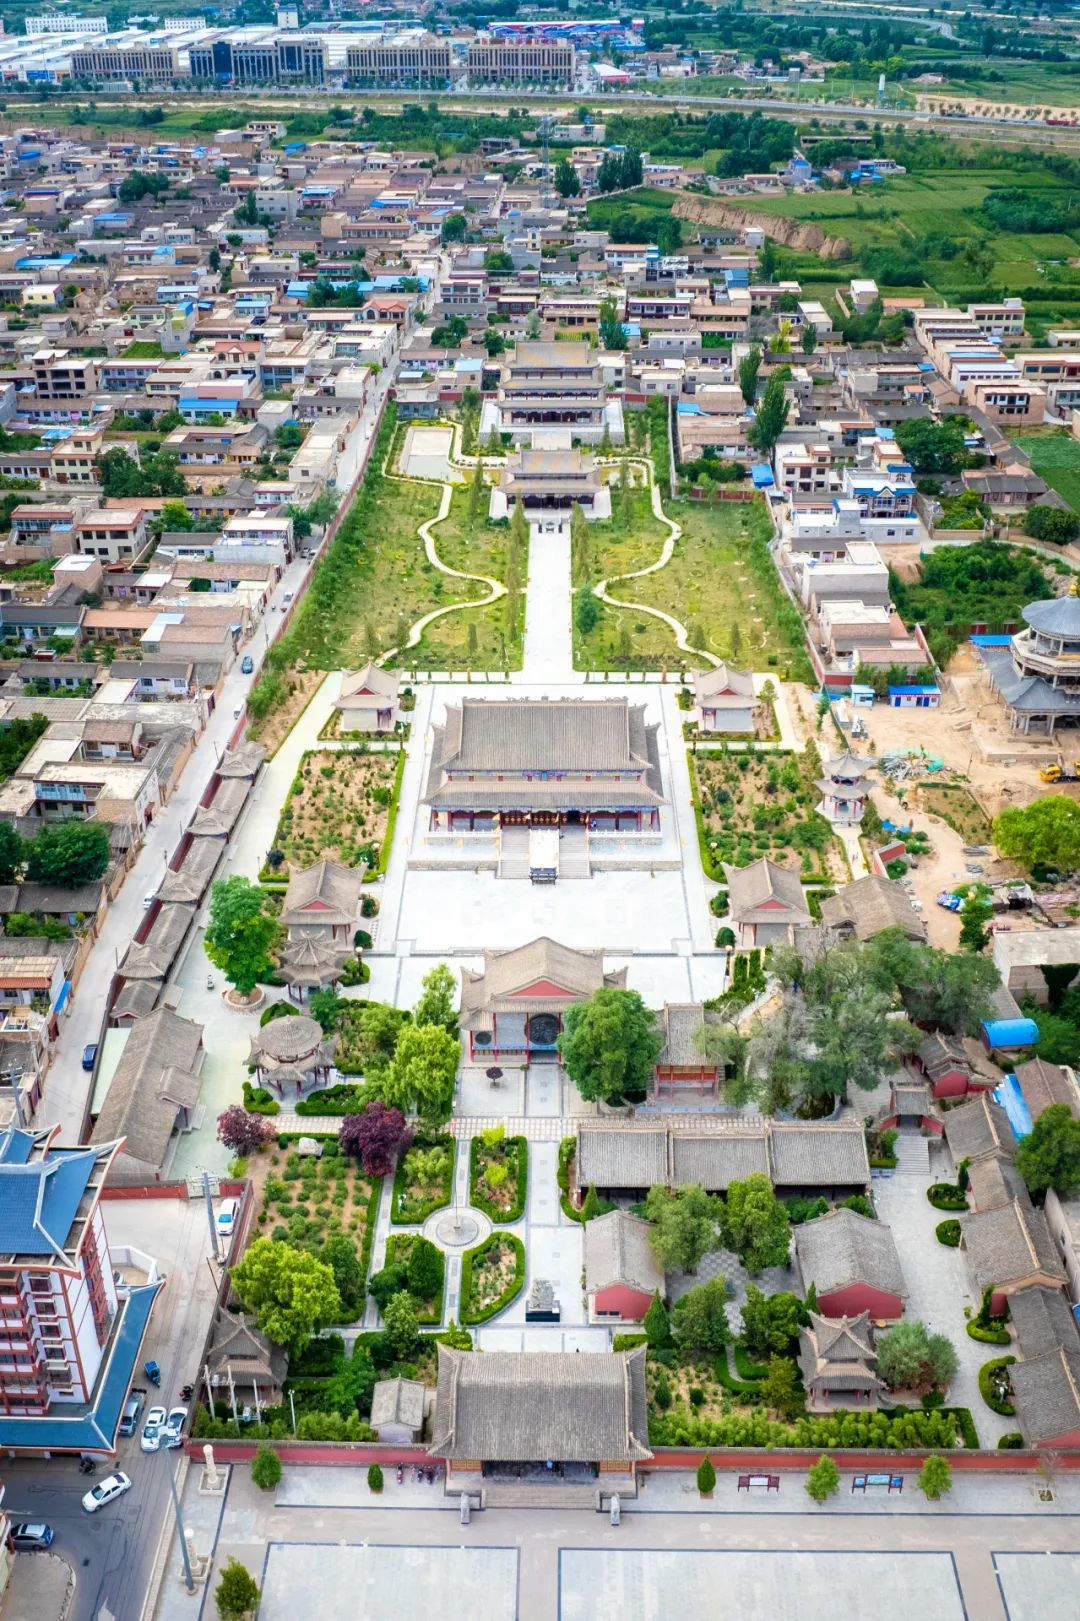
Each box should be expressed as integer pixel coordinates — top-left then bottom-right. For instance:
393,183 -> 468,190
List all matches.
274,749 -> 405,869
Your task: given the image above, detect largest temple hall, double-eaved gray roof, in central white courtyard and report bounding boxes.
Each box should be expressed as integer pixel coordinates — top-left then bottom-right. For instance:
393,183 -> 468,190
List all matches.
422,699 -> 665,835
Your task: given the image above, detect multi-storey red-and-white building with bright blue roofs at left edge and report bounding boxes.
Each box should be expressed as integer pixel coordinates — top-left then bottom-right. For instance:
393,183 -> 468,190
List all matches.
0,1127 -> 162,1452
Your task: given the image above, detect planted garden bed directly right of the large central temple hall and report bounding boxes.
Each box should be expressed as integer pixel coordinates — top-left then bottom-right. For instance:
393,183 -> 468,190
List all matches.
689,746 -> 848,882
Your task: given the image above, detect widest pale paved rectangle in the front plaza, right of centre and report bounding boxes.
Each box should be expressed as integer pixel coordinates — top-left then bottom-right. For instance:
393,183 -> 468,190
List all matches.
558,1548 -> 960,1621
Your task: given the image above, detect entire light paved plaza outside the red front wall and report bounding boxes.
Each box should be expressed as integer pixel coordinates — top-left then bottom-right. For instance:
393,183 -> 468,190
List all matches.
157,1464 -> 1080,1621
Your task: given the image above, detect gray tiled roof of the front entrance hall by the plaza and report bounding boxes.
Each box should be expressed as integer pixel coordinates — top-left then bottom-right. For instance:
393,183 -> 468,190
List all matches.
430,1345 -> 652,1464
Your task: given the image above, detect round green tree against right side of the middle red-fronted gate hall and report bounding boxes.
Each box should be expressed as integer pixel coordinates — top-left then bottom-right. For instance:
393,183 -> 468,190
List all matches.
559,986 -> 663,1102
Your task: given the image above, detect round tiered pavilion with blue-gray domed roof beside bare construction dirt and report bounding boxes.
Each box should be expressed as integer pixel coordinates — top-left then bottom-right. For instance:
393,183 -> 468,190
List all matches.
979,595 -> 1080,736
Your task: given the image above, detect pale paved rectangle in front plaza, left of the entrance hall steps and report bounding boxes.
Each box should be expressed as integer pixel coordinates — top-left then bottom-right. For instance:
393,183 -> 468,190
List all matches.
259,1542 -> 518,1621
